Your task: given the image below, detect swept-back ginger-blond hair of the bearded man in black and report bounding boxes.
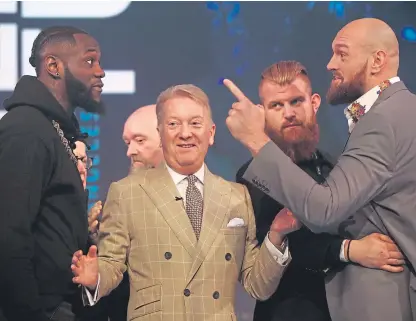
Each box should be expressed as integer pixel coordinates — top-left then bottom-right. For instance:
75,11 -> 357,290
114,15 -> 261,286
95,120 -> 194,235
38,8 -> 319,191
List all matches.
261,60 -> 311,87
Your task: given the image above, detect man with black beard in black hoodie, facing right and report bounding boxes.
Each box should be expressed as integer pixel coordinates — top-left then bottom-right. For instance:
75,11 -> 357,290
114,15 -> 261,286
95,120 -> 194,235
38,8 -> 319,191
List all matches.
0,27 -> 105,321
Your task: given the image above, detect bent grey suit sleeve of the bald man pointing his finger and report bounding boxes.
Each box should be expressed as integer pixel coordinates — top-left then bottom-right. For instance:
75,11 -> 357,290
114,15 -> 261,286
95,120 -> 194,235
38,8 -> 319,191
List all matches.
240,112 -> 395,233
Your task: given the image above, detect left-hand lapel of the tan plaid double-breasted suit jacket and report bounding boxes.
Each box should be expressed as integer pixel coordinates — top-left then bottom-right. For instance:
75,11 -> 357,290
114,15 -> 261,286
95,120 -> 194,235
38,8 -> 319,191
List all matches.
142,164 -> 196,257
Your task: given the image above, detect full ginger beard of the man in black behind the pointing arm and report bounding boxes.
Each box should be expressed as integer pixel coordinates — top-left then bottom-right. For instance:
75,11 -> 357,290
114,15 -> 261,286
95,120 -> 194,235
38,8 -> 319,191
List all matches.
266,119 -> 319,163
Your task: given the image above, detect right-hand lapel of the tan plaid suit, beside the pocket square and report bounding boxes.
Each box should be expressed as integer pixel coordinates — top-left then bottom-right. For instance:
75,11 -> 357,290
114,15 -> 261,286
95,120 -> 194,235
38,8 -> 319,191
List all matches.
186,166 -> 231,284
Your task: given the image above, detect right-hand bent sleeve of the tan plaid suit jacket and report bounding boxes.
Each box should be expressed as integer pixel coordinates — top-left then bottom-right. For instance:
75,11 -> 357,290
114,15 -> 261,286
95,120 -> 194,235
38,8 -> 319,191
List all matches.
240,186 -> 291,300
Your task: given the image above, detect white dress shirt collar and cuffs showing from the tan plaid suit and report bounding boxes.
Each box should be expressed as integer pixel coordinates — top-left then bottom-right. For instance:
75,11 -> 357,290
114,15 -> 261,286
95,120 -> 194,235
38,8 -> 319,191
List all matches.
83,164 -> 289,306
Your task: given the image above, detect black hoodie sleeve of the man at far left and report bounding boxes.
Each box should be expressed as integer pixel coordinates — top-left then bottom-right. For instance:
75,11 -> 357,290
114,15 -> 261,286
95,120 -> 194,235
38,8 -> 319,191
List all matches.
0,135 -> 52,321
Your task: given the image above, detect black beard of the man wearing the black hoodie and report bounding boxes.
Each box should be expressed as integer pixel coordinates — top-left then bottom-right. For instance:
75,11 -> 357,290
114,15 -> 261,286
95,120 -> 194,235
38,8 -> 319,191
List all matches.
65,68 -> 105,115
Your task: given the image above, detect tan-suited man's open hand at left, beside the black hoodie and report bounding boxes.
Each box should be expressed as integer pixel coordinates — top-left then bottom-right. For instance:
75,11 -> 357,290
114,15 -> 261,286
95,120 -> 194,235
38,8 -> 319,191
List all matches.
71,245 -> 98,289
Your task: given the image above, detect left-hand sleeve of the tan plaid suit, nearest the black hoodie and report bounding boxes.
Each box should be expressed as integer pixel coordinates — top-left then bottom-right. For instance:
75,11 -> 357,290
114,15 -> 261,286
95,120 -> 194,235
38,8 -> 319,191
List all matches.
97,183 -> 130,300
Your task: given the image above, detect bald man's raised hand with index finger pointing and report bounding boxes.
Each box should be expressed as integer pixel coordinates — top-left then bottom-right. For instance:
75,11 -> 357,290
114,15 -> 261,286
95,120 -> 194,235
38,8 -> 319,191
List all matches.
223,79 -> 270,155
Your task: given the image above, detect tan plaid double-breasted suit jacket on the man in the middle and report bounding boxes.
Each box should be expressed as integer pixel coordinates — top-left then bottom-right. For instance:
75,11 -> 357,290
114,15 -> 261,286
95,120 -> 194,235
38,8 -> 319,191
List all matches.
98,165 -> 285,321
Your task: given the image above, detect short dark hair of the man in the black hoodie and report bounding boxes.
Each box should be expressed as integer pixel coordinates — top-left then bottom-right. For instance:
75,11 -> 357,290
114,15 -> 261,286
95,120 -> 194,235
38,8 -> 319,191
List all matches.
29,26 -> 88,74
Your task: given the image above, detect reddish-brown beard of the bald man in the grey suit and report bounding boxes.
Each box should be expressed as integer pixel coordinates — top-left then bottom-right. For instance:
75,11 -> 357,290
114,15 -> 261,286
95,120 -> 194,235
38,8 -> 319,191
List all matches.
326,63 -> 367,105
